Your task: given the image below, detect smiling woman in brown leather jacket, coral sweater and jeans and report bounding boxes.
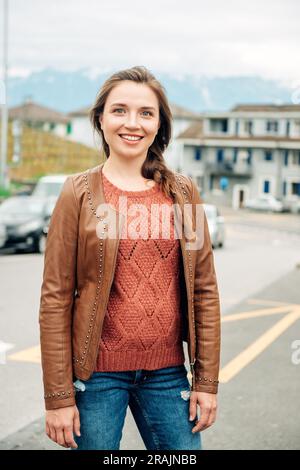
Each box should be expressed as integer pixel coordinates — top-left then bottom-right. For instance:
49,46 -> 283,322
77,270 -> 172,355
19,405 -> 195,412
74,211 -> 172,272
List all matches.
39,67 -> 220,450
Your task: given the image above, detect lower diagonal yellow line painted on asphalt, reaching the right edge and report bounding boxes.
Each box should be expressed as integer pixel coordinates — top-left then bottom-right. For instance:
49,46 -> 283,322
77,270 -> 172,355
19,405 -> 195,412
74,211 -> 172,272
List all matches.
219,307 -> 300,383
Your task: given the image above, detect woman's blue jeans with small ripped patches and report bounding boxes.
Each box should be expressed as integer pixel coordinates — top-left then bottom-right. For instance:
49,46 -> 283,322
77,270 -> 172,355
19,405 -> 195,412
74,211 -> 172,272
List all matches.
72,364 -> 201,450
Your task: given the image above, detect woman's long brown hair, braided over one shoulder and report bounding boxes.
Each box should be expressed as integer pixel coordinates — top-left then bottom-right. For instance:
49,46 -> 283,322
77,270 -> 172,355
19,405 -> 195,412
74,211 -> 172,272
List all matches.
89,66 -> 180,204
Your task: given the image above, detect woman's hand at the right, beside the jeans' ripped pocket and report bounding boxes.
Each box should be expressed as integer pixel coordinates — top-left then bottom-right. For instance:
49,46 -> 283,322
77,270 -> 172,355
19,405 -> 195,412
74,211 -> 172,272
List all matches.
190,392 -> 217,433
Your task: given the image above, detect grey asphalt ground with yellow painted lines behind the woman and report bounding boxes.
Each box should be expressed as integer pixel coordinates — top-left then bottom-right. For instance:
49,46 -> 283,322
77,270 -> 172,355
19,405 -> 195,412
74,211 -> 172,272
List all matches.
0,209 -> 300,450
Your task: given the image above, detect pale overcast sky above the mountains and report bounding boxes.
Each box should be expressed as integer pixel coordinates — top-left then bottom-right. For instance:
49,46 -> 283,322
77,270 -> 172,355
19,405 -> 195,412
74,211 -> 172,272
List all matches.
0,0 -> 300,81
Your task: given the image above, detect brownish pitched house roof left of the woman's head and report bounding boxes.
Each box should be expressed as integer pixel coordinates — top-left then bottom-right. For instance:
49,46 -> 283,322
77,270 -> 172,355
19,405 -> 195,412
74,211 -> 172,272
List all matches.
8,101 -> 68,123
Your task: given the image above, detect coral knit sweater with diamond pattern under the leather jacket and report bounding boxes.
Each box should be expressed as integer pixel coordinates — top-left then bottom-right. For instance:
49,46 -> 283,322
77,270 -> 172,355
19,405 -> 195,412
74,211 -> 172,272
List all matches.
95,172 -> 185,372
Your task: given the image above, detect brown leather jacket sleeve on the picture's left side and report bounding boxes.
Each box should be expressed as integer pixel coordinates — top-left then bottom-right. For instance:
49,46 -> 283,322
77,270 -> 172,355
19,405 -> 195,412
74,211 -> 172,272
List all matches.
39,176 -> 79,410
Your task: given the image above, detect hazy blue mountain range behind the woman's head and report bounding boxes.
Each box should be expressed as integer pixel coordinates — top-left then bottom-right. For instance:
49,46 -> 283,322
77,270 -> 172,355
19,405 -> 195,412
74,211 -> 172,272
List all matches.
8,68 -> 292,113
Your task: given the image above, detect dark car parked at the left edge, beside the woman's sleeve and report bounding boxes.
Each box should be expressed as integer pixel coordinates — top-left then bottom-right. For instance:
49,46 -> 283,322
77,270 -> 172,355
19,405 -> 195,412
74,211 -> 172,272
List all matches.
0,196 -> 56,253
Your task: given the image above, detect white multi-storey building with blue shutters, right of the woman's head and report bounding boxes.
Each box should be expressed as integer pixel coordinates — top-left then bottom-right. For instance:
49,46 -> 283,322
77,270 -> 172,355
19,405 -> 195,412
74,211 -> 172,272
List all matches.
176,104 -> 300,208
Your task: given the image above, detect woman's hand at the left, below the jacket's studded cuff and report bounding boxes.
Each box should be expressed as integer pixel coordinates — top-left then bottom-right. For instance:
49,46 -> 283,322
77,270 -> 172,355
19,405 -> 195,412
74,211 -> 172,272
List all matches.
46,405 -> 80,449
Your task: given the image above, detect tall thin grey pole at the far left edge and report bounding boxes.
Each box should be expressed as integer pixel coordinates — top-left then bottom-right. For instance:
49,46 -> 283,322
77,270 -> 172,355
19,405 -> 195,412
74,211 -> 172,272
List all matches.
0,0 -> 9,189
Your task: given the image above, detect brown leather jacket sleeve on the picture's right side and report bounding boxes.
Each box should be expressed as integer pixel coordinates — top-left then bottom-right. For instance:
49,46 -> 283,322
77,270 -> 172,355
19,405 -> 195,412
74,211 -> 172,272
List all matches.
191,180 -> 221,393
